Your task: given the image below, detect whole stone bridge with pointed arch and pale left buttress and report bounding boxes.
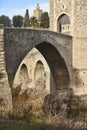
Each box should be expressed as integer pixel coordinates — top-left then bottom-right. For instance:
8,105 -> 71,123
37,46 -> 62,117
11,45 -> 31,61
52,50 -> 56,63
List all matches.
0,28 -> 86,109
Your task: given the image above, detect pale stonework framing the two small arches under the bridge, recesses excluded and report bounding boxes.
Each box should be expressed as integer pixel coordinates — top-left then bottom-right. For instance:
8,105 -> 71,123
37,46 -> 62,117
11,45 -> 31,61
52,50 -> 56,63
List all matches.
12,48 -> 50,93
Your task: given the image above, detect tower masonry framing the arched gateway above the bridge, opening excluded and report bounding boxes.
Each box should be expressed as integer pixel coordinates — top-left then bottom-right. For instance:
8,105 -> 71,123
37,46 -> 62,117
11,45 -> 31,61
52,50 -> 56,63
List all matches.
50,0 -> 74,35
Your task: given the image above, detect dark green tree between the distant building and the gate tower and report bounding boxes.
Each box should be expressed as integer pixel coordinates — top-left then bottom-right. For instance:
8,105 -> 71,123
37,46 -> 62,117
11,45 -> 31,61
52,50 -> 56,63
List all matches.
41,12 -> 49,28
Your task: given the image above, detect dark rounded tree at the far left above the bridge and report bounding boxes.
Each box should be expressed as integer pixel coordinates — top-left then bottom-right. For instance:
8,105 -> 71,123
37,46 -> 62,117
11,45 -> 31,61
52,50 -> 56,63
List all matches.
0,15 -> 11,27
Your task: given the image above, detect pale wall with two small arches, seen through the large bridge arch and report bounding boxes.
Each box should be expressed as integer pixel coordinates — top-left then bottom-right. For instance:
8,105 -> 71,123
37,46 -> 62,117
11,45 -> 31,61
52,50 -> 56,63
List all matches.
13,48 -> 51,93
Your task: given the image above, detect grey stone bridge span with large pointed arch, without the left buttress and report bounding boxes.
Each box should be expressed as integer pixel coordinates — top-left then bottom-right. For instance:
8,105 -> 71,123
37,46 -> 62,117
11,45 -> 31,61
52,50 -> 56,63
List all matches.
5,29 -> 72,93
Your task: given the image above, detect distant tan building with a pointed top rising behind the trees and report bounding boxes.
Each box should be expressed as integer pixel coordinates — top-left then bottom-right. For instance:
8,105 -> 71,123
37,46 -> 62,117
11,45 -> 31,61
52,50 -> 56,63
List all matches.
33,4 -> 42,23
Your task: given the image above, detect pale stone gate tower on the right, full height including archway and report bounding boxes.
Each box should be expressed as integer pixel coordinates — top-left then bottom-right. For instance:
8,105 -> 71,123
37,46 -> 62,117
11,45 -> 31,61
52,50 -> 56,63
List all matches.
50,0 -> 87,95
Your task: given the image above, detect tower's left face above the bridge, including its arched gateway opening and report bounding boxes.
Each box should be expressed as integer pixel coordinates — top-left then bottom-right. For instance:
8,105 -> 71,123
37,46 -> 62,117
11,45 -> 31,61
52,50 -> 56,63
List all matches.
50,0 -> 75,35
